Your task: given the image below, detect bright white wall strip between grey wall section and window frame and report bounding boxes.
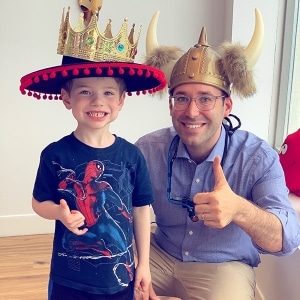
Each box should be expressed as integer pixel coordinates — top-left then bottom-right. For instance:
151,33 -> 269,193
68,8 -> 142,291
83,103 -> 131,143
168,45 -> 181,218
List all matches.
232,0 -> 279,140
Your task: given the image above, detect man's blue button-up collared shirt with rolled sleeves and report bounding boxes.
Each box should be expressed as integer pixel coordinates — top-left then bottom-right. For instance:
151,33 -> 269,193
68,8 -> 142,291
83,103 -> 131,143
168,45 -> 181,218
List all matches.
136,127 -> 300,267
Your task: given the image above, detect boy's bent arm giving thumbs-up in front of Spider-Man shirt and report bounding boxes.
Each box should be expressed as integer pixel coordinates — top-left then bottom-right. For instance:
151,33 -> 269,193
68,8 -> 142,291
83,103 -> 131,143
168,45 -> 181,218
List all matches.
32,197 -> 88,235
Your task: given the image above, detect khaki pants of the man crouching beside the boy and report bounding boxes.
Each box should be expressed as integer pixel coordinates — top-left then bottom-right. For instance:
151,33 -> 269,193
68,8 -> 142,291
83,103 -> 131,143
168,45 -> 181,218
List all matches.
150,234 -> 255,300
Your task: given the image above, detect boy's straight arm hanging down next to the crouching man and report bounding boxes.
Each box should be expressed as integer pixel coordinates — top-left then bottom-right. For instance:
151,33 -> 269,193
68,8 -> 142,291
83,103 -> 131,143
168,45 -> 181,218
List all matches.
133,205 -> 151,299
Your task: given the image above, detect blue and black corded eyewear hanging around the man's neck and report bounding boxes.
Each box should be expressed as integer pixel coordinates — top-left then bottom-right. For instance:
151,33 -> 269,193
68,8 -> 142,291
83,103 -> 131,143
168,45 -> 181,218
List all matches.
167,114 -> 242,222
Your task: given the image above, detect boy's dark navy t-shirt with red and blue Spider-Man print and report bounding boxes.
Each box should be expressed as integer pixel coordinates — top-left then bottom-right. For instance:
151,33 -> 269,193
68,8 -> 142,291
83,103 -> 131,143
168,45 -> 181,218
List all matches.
33,134 -> 153,294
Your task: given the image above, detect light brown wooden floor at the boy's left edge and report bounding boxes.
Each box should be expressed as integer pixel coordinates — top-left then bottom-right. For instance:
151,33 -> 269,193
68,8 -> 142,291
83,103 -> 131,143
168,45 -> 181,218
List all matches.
0,234 -> 53,300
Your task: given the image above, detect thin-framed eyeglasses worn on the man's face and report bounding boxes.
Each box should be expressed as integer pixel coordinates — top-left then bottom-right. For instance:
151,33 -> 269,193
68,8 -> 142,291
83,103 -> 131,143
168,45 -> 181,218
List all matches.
170,94 -> 226,111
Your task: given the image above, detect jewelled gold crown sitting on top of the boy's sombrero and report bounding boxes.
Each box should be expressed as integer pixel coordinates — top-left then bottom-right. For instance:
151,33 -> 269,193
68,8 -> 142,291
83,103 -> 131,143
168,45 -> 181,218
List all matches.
57,7 -> 141,62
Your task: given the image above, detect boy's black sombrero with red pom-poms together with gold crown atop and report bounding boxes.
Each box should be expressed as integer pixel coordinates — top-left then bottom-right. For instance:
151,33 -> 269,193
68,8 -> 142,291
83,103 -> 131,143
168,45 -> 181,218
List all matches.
20,3 -> 166,100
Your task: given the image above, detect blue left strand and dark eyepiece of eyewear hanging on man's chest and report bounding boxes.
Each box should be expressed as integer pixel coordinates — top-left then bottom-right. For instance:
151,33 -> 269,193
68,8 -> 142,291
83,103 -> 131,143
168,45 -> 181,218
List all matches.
167,135 -> 199,222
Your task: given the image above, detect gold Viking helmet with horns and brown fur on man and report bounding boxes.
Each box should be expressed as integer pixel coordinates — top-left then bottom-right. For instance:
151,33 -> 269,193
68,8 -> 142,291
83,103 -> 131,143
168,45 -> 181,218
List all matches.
145,9 -> 264,98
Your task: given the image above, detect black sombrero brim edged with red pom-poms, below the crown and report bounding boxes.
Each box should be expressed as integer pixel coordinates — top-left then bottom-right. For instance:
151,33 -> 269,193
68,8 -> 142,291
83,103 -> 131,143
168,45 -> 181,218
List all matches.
20,58 -> 166,100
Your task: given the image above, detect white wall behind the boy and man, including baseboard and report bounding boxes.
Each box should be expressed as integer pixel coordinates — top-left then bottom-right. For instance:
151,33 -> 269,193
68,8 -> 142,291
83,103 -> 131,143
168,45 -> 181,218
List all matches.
0,0 -> 279,236
